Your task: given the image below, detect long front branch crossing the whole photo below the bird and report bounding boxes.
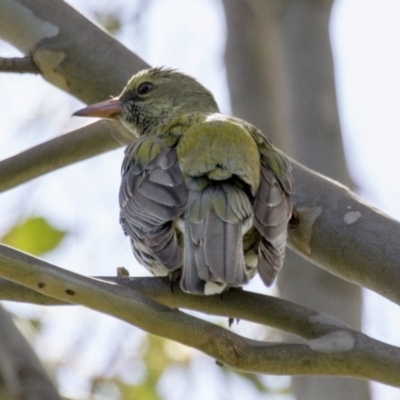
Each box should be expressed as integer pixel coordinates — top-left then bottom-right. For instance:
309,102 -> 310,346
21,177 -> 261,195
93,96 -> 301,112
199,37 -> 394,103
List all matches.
0,246 -> 400,387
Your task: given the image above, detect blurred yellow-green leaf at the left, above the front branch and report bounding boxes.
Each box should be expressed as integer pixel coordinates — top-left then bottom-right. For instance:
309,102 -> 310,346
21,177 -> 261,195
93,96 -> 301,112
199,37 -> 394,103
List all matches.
0,217 -> 67,256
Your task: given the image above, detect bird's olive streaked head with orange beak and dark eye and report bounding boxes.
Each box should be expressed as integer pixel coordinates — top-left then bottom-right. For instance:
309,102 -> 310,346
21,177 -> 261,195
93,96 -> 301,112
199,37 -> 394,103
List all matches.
73,68 -> 218,135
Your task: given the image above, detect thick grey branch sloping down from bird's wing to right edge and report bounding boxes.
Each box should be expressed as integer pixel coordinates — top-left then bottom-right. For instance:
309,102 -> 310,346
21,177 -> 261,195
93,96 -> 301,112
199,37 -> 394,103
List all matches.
289,162 -> 400,304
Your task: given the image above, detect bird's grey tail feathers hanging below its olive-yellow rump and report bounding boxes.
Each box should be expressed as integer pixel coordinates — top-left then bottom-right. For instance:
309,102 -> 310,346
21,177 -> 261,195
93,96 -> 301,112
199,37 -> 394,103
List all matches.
181,182 -> 252,294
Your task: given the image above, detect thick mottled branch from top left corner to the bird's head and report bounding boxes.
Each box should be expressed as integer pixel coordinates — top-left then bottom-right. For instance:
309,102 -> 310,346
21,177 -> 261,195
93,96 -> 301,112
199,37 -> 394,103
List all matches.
0,0 -> 148,103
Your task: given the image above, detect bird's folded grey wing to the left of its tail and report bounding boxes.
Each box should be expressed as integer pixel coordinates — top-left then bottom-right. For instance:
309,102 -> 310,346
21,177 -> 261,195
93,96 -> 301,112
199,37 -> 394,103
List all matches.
119,137 -> 188,275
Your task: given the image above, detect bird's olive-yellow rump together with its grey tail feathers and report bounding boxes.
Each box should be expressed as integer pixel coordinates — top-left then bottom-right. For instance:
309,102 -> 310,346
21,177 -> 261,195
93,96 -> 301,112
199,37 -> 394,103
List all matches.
177,114 -> 260,294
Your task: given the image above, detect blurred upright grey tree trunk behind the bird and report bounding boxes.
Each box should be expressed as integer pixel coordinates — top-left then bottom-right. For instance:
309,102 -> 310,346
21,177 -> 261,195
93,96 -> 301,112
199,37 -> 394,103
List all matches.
224,0 -> 369,400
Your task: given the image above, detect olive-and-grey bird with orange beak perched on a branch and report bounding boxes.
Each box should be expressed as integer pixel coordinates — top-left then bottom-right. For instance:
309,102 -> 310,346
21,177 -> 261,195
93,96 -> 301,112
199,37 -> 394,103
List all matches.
74,67 -> 293,295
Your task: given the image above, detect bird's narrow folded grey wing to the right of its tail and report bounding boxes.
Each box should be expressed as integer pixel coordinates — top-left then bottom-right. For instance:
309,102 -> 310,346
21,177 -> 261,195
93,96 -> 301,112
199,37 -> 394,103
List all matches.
254,141 -> 293,285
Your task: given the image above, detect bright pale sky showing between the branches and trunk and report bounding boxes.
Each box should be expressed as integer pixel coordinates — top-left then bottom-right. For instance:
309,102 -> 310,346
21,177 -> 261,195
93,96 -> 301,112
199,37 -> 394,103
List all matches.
0,0 -> 400,400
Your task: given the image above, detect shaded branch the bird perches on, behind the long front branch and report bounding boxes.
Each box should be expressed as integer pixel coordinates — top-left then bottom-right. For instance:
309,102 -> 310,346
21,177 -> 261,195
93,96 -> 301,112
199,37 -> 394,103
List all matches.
0,277 -> 350,339
